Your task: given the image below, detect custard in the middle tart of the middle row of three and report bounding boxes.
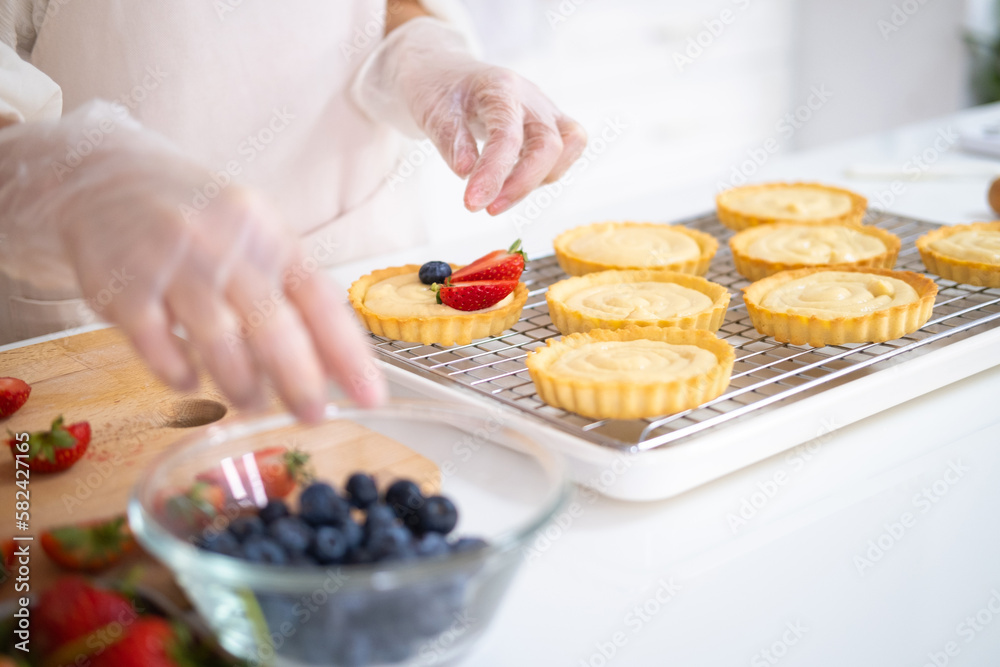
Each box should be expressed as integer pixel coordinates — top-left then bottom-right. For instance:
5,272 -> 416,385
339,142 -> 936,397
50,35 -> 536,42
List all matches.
565,282 -> 712,320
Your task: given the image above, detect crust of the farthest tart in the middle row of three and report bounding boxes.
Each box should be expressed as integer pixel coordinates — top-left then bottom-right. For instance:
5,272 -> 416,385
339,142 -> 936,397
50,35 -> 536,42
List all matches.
552,222 -> 719,276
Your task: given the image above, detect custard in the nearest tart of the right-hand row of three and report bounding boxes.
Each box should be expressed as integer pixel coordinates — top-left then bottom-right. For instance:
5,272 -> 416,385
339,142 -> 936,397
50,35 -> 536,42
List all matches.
761,271 -> 919,317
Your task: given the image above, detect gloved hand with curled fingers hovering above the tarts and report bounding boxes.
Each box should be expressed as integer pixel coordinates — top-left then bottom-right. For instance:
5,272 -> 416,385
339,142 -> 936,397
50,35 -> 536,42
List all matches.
352,18 -> 587,215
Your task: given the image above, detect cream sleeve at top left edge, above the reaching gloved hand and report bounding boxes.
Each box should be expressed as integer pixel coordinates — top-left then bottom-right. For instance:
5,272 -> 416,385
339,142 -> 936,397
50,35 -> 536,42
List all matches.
0,0 -> 62,125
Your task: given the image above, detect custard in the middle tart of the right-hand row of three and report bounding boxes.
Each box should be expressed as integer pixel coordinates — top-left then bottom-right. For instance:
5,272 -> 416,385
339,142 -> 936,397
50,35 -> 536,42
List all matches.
745,225 -> 887,264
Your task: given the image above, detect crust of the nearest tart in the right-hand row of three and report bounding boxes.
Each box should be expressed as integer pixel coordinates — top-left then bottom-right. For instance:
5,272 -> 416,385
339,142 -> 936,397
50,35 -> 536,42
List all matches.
743,265 -> 937,347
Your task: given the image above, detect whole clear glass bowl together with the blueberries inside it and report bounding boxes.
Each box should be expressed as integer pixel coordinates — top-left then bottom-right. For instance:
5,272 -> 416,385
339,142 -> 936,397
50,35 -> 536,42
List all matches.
129,401 -> 570,667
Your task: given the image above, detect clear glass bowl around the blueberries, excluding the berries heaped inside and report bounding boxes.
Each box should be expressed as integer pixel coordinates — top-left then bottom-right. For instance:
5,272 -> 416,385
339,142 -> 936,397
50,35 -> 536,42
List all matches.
129,401 -> 570,666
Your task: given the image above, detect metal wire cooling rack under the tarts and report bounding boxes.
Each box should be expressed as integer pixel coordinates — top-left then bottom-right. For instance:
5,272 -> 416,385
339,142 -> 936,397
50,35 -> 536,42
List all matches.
371,213 -> 1000,451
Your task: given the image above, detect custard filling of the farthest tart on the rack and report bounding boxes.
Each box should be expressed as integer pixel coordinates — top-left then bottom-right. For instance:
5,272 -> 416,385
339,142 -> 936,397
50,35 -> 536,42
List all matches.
725,185 -> 852,220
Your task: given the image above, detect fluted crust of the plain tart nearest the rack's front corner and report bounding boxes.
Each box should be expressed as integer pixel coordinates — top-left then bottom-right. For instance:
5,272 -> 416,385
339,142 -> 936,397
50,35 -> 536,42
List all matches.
526,326 -> 736,419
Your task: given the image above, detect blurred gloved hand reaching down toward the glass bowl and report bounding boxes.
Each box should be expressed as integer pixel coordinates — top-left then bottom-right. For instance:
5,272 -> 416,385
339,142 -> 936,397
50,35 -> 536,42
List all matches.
0,102 -> 385,421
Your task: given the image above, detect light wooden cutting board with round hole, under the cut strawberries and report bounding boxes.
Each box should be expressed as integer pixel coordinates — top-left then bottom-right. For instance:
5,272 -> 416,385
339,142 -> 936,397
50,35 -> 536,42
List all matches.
0,328 -> 437,599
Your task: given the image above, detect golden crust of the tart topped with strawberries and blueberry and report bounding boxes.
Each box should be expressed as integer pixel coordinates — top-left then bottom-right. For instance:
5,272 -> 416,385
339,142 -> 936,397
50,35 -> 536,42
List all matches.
347,264 -> 528,345
